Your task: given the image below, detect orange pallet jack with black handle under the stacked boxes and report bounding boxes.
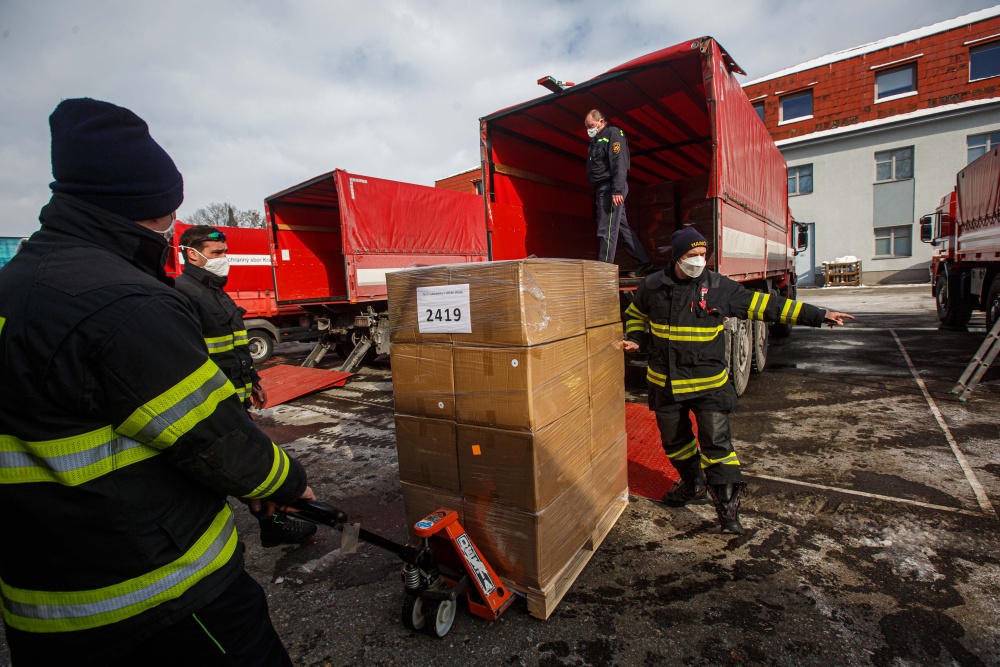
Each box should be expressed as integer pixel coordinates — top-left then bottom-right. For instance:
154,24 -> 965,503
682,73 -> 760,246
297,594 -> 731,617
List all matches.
292,500 -> 514,639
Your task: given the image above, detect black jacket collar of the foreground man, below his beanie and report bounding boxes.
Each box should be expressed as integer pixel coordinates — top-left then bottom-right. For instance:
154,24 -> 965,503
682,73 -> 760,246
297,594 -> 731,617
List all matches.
38,192 -> 174,286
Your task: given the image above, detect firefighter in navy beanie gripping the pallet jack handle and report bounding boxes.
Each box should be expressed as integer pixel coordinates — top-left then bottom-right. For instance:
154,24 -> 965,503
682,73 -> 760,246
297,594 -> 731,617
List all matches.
0,99 -> 315,666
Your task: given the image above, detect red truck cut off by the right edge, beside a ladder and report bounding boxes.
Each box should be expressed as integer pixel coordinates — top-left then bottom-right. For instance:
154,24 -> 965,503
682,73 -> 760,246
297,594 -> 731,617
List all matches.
920,148 -> 1000,330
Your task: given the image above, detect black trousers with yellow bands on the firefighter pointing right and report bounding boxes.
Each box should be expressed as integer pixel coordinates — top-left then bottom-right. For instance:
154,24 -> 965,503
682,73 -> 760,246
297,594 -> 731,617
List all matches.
649,382 -> 743,484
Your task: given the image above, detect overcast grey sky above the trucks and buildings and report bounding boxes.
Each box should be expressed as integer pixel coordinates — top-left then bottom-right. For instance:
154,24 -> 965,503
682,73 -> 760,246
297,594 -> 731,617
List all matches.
0,0 -> 995,236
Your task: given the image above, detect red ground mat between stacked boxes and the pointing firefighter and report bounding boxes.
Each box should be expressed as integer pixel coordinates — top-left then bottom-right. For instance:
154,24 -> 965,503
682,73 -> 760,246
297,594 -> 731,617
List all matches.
625,403 -> 698,500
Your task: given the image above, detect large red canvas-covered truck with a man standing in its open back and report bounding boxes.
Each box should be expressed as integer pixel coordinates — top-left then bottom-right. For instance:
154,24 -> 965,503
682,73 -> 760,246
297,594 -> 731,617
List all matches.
480,37 -> 806,393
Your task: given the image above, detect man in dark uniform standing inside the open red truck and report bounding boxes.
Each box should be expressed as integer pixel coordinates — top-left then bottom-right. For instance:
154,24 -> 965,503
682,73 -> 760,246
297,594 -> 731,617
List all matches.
583,109 -> 649,277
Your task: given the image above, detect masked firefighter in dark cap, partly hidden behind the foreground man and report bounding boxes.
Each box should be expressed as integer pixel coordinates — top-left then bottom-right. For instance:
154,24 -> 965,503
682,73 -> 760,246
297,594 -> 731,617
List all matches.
175,225 -> 316,547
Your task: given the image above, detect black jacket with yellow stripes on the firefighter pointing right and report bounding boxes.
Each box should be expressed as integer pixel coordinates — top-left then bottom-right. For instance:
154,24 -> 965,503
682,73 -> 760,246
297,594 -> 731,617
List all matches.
625,265 -> 826,399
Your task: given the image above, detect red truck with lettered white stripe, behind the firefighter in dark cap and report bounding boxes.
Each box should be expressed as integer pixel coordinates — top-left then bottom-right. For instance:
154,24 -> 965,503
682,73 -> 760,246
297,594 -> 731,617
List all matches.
166,220 -> 321,364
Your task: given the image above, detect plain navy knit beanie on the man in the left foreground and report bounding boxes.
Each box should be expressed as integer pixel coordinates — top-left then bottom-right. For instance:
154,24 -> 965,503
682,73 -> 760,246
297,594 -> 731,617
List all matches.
49,98 -> 184,220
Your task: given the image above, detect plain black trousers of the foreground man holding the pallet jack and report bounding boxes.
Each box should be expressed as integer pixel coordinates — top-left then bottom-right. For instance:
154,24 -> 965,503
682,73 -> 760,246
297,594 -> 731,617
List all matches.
113,572 -> 292,667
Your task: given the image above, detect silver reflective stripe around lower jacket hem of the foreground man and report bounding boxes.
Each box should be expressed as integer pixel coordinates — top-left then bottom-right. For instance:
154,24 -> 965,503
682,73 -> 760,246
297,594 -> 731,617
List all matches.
3,514 -> 236,620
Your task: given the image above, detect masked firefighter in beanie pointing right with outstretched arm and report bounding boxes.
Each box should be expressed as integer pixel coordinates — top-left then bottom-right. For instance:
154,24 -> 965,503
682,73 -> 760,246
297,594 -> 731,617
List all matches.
620,227 -> 853,534
